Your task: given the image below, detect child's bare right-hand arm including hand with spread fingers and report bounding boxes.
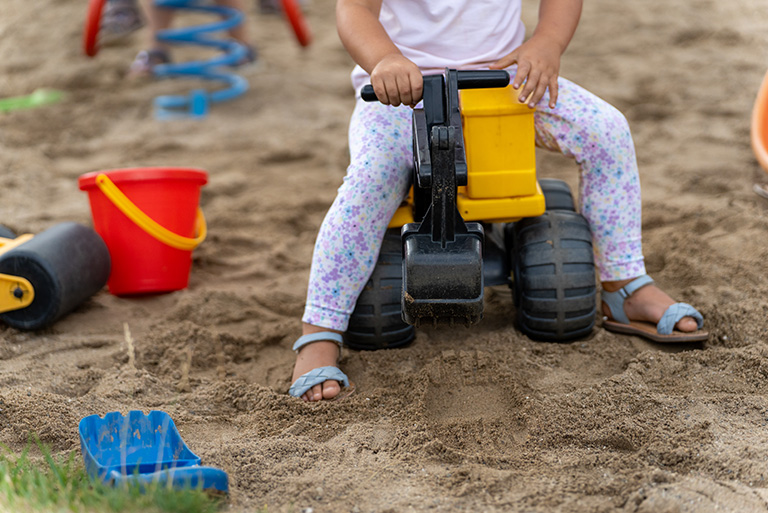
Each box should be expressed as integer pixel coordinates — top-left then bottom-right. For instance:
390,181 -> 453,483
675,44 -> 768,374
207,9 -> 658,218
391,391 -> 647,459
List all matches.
490,0 -> 582,108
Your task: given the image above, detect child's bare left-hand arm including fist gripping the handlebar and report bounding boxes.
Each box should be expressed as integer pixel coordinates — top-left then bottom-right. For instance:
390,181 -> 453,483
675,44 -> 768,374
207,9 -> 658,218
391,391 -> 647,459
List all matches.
336,0 -> 423,106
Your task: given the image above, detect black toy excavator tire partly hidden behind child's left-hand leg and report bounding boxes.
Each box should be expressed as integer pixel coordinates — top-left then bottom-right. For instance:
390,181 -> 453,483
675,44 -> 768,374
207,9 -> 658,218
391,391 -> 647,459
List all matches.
344,229 -> 416,351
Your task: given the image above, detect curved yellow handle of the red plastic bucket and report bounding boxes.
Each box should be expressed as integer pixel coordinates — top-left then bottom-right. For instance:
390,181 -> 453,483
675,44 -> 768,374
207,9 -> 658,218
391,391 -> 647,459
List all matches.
96,173 -> 208,251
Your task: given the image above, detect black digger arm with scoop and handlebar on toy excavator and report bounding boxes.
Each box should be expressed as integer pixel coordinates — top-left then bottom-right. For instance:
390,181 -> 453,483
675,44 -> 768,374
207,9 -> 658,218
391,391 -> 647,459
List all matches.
362,69 -> 509,326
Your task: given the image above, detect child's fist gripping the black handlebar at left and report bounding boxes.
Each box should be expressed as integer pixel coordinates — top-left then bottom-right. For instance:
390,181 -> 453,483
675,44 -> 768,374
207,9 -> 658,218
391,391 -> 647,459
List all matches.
371,53 -> 424,107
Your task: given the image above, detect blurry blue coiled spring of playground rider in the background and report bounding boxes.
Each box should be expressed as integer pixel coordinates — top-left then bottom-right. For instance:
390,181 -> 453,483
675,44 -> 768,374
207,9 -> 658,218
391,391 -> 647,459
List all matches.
154,0 -> 249,120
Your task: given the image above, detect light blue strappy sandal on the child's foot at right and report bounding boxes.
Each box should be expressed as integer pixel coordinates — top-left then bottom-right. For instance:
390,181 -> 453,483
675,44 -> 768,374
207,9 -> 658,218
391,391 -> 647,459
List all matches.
601,274 -> 709,343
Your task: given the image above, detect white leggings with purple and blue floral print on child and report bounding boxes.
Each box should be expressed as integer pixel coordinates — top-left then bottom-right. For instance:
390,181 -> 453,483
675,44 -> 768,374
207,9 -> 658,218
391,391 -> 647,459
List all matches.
302,78 -> 645,331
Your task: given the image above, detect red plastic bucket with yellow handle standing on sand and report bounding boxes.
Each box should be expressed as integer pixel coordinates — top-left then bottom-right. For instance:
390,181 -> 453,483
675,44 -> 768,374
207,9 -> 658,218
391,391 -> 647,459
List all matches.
78,167 -> 208,296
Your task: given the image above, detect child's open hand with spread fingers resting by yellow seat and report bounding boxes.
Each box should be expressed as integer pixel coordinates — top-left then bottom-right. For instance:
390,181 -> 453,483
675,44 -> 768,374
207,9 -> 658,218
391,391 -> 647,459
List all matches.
490,36 -> 561,108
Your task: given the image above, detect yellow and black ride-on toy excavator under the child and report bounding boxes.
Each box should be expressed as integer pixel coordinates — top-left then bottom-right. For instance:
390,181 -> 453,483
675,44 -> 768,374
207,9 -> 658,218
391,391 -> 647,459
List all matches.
345,69 -> 596,349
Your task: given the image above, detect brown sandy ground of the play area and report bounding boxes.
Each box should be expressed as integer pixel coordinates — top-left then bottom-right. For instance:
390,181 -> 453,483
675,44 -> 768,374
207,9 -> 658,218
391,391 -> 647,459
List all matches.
0,0 -> 768,513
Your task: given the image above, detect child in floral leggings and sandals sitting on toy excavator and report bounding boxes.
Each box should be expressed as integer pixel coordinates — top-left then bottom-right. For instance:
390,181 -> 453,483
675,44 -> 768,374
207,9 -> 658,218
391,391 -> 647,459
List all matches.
290,0 -> 707,401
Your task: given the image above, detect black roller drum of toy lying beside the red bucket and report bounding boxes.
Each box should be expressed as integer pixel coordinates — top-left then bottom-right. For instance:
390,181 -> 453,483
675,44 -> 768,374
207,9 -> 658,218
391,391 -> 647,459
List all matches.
0,223 -> 111,330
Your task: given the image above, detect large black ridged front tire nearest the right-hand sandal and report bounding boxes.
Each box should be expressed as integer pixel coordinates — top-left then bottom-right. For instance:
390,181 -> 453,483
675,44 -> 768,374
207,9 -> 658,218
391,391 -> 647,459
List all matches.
506,210 -> 597,342
